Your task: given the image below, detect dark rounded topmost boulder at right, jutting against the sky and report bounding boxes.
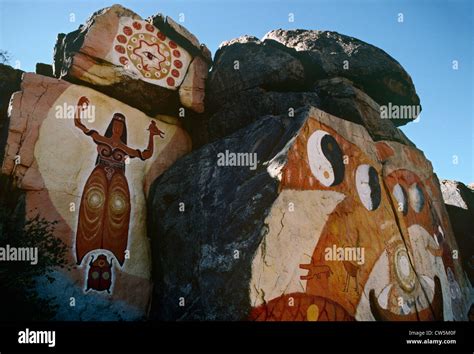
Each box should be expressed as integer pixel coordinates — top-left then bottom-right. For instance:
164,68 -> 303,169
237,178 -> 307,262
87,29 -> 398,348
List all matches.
263,29 -> 421,126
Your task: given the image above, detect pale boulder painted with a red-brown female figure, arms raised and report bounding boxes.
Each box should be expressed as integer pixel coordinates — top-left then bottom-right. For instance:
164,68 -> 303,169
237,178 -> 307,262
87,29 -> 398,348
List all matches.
2,73 -> 191,320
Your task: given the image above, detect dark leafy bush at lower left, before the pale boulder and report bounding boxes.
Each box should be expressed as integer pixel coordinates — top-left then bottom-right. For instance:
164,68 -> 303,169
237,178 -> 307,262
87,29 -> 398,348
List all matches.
0,203 -> 67,321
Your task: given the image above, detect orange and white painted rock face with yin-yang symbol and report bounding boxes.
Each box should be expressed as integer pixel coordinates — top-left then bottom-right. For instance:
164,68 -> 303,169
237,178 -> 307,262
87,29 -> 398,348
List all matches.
250,110 -> 462,321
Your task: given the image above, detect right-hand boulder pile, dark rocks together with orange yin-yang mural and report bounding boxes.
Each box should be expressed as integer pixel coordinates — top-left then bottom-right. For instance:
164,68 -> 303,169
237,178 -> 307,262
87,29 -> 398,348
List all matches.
148,30 -> 472,321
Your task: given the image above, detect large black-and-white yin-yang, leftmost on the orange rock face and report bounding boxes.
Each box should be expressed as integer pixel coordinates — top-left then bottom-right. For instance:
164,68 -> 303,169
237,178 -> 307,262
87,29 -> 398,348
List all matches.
307,130 -> 344,187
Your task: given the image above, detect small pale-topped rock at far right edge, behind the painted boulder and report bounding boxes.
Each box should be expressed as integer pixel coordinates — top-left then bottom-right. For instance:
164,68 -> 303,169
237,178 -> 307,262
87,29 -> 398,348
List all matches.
440,180 -> 474,284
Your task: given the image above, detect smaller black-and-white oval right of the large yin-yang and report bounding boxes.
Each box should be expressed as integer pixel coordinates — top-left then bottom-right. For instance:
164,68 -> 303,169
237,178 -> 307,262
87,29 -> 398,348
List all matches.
355,164 -> 382,210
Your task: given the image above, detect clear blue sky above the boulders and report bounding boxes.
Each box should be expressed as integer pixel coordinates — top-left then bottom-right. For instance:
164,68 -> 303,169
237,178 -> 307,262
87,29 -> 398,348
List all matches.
0,0 -> 474,183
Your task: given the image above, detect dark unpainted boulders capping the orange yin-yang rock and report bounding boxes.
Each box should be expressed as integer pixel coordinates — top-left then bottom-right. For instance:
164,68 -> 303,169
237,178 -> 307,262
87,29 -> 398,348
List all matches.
207,31 -> 419,145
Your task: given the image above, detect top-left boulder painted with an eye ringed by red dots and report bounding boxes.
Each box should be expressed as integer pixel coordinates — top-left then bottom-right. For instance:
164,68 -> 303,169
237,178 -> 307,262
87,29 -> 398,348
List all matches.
54,5 -> 210,117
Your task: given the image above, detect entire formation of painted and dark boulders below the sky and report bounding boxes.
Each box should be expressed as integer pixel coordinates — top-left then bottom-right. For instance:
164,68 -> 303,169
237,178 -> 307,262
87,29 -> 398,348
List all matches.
0,5 -> 473,321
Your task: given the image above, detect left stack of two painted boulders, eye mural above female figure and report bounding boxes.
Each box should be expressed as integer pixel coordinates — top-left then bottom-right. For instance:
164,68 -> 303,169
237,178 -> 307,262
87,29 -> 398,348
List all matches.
0,5 -> 210,320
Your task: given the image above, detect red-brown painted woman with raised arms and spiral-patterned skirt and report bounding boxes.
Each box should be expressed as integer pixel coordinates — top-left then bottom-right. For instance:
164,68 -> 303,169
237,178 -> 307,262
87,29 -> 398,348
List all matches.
74,96 -> 164,266
